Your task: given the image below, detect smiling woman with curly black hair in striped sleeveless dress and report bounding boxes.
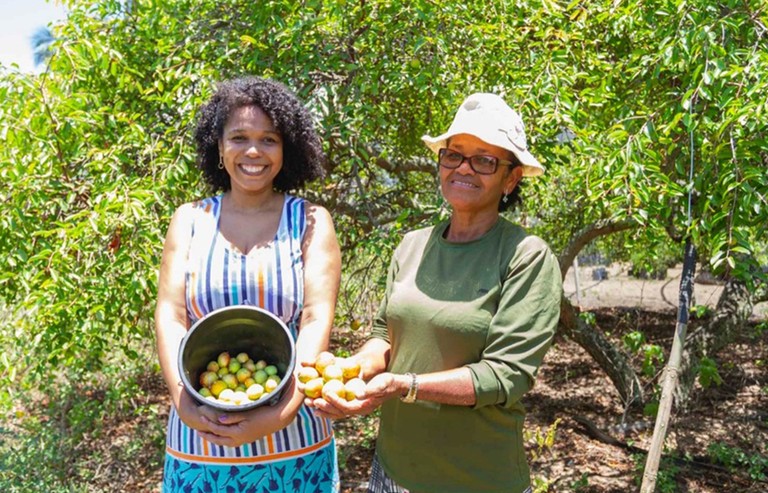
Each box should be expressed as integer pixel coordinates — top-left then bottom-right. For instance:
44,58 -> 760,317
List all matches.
155,77 -> 340,492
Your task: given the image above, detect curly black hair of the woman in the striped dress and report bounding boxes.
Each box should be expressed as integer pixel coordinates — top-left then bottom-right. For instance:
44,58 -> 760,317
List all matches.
194,76 -> 325,193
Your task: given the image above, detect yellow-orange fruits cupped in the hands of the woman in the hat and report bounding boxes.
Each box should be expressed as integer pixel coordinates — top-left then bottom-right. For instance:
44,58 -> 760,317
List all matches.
297,351 -> 365,401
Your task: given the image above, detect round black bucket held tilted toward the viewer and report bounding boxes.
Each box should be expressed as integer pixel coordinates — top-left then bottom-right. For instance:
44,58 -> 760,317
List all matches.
178,305 -> 296,412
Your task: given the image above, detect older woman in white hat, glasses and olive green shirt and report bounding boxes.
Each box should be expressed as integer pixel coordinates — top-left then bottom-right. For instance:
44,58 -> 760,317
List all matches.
308,94 -> 562,493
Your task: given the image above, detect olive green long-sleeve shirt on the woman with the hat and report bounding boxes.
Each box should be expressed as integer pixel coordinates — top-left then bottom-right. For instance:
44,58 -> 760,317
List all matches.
372,218 -> 562,493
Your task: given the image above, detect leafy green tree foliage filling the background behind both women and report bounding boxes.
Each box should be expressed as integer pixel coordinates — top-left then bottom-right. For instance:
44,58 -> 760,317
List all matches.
0,0 -> 768,416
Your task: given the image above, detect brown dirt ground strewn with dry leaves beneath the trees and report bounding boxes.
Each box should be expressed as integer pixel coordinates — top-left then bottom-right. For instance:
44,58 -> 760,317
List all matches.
105,266 -> 768,493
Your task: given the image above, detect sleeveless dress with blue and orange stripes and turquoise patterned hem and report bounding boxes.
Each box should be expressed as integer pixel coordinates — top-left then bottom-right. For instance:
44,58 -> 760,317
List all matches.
163,194 -> 339,493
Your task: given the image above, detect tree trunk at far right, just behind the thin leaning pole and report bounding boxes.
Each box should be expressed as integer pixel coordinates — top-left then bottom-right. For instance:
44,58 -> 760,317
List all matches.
675,279 -> 754,410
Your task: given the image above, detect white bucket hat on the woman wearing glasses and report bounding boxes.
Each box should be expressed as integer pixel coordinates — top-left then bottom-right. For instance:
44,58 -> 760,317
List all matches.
421,93 -> 544,176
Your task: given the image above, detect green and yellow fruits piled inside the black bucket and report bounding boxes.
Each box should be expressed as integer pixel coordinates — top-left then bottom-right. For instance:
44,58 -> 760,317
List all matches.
198,351 -> 282,405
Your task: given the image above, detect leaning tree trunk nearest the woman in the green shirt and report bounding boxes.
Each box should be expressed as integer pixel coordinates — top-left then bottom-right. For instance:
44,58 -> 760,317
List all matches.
560,296 -> 643,407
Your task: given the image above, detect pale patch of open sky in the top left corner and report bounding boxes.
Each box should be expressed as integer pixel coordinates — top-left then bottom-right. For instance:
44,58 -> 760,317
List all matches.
0,0 -> 66,72
